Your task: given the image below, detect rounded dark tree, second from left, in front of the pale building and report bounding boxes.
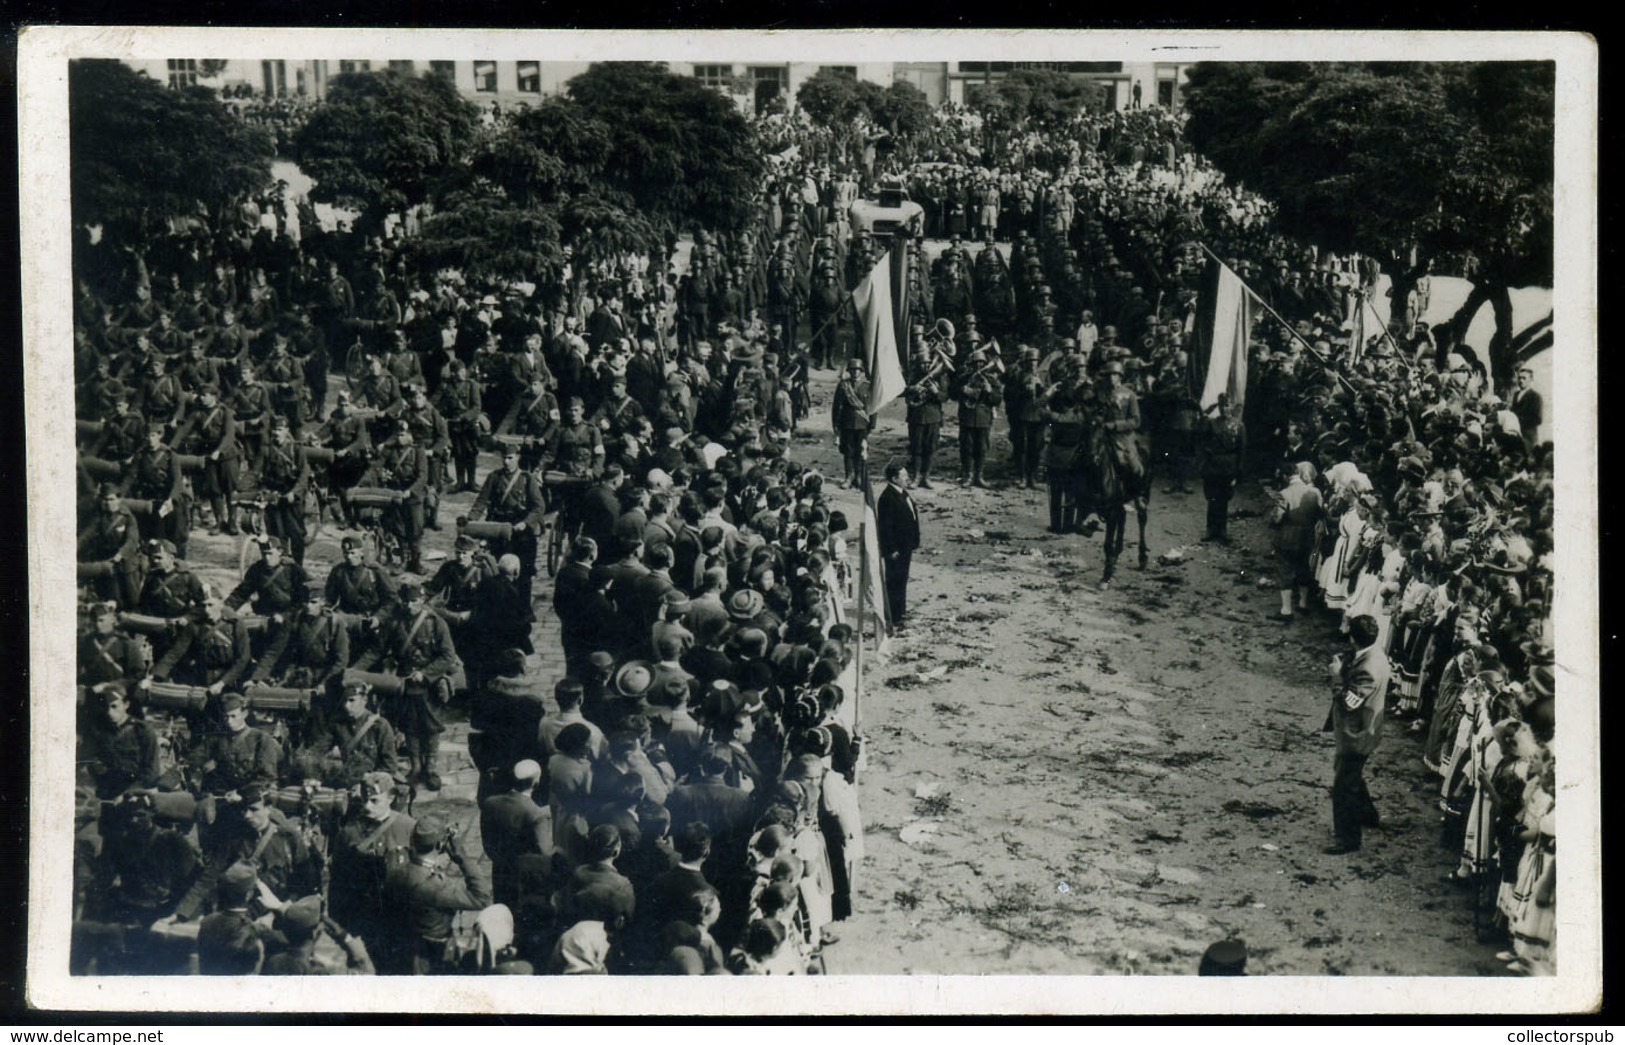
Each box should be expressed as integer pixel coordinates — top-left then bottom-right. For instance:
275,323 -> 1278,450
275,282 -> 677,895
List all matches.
294,72 -> 479,237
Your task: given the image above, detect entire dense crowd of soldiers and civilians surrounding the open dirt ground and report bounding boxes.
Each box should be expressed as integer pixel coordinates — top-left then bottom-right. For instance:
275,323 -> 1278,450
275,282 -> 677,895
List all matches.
73,75 -> 1555,973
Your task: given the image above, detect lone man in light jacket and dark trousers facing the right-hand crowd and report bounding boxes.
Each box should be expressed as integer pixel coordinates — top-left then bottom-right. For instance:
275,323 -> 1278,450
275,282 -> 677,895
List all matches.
1326,614 -> 1389,856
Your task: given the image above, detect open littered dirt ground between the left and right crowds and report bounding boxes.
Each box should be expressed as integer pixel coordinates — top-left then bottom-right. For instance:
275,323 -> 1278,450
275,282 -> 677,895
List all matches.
796,374 -> 1500,975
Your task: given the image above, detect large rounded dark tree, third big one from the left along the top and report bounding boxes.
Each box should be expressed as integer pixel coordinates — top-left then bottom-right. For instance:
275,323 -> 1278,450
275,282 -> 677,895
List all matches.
567,62 -> 762,229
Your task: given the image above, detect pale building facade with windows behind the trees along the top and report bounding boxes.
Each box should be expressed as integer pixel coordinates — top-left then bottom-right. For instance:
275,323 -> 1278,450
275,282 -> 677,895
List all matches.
130,59 -> 1191,114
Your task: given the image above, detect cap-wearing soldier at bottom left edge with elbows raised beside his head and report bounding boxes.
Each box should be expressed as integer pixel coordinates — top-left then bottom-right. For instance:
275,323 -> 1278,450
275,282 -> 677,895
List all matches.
380,817 -> 491,975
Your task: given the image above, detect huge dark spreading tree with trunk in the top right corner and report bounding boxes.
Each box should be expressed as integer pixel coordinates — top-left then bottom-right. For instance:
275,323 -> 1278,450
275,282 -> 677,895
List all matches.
1185,62 -> 1555,384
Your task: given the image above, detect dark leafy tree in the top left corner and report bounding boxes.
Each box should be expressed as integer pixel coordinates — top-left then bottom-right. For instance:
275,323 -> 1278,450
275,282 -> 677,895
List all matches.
68,59 -> 271,247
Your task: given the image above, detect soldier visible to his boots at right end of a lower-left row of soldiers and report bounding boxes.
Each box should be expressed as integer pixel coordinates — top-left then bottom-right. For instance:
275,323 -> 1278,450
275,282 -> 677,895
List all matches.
356,580 -> 460,791
